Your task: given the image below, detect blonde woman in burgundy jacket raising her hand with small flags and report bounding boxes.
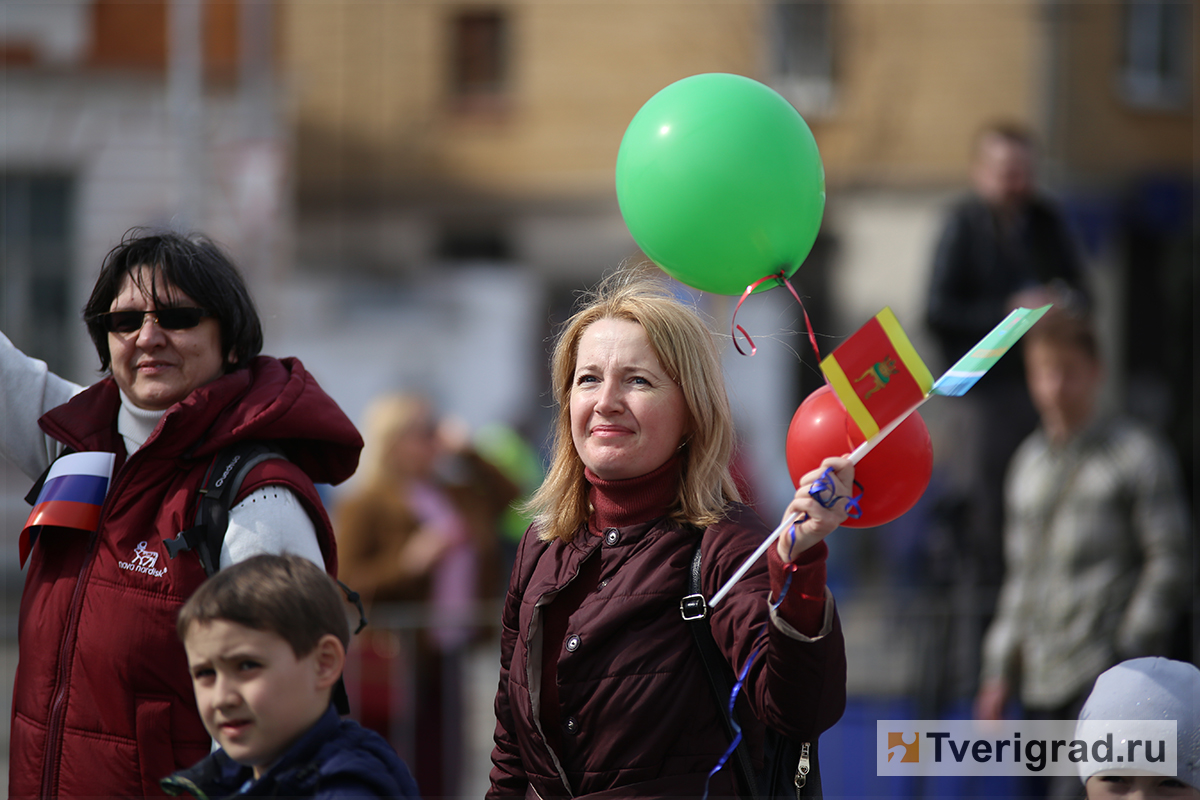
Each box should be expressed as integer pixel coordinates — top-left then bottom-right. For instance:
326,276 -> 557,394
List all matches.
487,269 -> 854,798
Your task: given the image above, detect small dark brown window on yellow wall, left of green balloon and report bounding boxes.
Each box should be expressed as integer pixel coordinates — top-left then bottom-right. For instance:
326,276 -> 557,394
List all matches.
450,8 -> 509,108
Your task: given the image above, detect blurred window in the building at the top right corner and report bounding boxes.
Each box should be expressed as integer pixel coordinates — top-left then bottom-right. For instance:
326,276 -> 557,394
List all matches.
1120,0 -> 1192,109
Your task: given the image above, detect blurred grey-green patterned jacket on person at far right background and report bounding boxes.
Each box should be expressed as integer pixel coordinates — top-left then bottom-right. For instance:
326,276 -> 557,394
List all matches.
983,419 -> 1189,708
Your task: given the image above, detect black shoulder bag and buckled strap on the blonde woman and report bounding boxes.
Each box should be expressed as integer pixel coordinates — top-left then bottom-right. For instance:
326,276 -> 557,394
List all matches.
679,537 -> 821,800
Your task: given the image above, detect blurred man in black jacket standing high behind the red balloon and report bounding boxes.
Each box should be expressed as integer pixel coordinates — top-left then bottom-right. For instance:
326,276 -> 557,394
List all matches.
926,122 -> 1088,706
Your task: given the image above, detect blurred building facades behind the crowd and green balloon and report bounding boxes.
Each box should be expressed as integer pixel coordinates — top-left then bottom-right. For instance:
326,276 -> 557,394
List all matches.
0,0 -> 1198,796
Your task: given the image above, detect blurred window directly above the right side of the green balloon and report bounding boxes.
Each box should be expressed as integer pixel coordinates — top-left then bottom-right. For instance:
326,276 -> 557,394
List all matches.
768,0 -> 834,114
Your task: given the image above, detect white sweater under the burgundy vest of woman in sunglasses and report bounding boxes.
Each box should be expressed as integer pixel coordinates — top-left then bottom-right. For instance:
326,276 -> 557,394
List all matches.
0,333 -> 325,570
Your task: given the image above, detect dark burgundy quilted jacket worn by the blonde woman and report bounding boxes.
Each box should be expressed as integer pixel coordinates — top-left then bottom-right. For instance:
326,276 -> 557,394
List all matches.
488,504 -> 846,800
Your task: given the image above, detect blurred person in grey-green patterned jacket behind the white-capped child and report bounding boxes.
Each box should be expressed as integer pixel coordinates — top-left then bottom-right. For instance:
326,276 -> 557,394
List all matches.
976,311 -> 1190,798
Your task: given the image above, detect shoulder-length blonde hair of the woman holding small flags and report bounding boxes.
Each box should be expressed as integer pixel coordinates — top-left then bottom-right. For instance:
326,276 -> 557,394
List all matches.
527,265 -> 742,541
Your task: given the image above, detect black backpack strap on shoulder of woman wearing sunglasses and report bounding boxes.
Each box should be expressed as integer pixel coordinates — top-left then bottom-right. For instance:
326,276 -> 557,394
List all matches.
163,441 -> 287,577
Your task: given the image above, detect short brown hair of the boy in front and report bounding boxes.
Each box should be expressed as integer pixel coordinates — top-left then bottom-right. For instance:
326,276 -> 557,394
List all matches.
175,554 -> 350,658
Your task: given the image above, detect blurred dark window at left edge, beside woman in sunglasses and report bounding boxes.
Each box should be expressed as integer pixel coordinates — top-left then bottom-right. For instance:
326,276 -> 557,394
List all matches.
0,173 -> 78,375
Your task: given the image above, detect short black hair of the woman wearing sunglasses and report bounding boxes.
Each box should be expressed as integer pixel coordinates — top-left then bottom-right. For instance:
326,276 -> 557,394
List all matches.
83,228 -> 263,372
